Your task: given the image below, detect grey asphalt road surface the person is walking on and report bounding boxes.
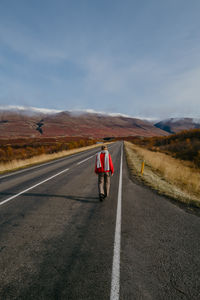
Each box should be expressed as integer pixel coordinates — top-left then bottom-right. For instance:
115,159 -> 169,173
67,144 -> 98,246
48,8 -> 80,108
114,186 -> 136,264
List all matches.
0,142 -> 200,300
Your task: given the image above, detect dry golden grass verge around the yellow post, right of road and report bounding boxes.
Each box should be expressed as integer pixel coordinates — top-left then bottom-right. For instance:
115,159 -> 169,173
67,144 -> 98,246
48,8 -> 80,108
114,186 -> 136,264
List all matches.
125,142 -> 200,206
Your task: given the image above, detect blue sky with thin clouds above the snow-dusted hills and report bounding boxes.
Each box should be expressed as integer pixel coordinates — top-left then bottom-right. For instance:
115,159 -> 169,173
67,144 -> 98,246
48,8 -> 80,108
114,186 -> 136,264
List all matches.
0,0 -> 200,118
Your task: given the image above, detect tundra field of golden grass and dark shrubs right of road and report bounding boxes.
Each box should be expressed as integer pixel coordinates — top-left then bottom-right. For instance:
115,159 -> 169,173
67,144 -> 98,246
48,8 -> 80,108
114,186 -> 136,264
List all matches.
125,130 -> 200,207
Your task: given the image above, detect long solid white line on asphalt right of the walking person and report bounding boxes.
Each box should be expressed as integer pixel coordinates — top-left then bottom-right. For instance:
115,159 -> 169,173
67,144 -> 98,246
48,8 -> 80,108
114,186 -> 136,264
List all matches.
110,146 -> 123,300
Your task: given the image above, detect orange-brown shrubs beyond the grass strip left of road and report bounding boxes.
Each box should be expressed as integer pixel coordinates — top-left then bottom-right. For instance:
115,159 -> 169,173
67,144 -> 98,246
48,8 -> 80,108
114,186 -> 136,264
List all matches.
0,137 -> 96,163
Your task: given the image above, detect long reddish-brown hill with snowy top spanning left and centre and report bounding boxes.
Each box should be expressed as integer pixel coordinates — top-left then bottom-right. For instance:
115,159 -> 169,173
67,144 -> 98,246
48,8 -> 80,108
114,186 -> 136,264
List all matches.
0,110 -> 167,138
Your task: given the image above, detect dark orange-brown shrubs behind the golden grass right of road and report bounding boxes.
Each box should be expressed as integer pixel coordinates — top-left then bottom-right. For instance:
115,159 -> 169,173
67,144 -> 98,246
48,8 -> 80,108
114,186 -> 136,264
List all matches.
123,129 -> 200,168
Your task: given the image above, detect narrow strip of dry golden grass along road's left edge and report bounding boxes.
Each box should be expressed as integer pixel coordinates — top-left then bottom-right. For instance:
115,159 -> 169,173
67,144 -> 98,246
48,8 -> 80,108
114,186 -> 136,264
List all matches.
0,143 -> 108,173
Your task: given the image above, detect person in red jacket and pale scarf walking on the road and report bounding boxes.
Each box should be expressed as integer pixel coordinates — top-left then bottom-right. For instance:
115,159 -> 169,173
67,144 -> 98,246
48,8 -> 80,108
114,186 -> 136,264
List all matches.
95,145 -> 114,201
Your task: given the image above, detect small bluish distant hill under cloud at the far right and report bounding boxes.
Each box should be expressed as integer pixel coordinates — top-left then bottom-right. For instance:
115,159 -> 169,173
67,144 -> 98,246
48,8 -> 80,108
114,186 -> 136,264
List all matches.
154,118 -> 200,133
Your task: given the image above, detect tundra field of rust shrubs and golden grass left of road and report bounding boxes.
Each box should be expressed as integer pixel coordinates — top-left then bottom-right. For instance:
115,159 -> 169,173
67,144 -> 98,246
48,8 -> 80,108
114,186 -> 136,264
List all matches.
0,137 -> 99,173
